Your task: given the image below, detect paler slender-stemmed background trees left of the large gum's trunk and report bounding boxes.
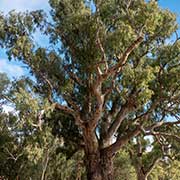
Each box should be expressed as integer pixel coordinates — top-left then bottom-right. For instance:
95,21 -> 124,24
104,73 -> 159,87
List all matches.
0,73 -> 84,180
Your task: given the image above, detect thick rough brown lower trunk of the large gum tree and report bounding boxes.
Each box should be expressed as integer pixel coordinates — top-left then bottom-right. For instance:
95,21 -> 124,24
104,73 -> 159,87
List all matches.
83,126 -> 113,180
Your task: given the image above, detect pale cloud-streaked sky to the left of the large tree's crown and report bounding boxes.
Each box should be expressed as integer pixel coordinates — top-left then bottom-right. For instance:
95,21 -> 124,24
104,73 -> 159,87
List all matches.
0,0 -> 50,78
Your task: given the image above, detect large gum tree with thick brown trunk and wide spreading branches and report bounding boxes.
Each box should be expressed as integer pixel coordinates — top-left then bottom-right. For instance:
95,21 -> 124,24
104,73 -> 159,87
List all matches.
0,0 -> 180,180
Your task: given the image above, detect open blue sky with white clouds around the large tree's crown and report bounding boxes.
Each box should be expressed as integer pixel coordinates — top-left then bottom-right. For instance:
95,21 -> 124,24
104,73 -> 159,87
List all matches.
0,0 -> 180,78
